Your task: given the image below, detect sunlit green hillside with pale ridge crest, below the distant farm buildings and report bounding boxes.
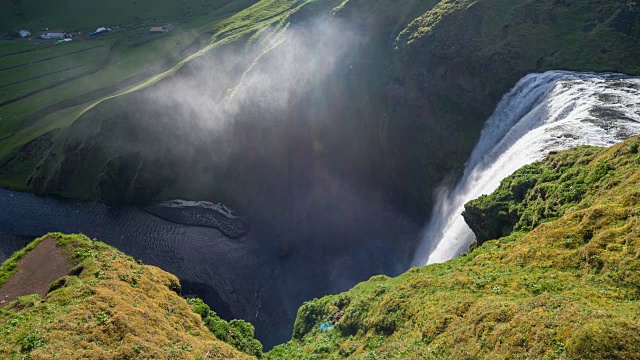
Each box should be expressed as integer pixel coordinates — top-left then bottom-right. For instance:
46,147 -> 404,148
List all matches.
0,0 -> 316,197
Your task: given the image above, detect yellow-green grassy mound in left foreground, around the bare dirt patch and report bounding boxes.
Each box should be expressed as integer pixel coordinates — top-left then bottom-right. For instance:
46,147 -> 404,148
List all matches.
0,234 -> 262,359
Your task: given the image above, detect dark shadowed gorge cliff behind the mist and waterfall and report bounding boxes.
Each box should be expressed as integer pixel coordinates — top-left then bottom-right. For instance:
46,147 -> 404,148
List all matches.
4,0 -> 640,220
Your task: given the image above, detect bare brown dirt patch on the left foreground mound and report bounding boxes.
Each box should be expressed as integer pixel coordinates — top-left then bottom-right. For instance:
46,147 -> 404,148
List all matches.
0,238 -> 72,307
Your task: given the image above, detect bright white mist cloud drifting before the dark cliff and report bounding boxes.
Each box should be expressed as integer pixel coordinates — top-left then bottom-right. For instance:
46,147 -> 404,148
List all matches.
137,18 -> 361,145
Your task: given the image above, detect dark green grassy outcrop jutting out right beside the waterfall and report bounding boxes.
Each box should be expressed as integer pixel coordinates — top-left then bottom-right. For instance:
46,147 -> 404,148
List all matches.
464,147 -> 609,243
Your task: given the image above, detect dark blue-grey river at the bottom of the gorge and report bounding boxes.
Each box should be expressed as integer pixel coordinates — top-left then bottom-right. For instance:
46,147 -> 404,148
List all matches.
0,189 -> 419,348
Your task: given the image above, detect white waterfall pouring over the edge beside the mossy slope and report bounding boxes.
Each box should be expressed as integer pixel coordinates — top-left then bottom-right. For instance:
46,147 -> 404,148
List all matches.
413,71 -> 640,266
